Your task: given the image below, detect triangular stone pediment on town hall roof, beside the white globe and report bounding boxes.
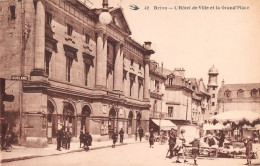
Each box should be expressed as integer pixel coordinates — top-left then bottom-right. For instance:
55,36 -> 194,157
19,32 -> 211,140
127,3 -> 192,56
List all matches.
109,8 -> 131,35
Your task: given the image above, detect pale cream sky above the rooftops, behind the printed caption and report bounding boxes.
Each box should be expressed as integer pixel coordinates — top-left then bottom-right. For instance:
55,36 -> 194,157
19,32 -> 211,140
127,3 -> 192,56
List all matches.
91,0 -> 260,85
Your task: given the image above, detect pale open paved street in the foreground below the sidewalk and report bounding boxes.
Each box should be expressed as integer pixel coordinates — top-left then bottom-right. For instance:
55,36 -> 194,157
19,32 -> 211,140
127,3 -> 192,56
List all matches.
2,142 -> 254,166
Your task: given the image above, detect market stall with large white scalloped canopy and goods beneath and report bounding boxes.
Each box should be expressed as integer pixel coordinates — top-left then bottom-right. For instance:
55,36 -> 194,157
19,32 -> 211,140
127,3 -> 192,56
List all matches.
209,110 -> 260,158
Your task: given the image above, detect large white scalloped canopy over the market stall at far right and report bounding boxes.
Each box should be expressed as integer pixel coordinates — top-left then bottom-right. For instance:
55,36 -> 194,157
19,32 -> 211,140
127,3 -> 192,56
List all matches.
209,110 -> 260,124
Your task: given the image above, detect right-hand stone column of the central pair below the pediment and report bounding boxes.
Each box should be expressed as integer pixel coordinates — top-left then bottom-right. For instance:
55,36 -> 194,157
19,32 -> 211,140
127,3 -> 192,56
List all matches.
114,42 -> 123,91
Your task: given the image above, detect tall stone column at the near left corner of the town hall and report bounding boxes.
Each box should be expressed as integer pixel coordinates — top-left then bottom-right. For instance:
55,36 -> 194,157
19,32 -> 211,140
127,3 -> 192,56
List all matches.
34,1 -> 45,71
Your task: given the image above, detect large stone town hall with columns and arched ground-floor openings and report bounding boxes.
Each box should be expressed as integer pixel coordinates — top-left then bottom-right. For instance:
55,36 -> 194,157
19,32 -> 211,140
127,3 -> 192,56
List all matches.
0,0 -> 154,142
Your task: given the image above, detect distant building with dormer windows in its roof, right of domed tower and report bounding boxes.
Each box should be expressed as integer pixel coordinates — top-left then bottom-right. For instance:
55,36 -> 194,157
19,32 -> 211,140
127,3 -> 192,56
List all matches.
218,81 -> 260,113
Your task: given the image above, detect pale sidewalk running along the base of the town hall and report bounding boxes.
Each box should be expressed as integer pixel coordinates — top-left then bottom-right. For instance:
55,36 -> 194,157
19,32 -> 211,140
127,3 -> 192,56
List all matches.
0,138 -> 147,163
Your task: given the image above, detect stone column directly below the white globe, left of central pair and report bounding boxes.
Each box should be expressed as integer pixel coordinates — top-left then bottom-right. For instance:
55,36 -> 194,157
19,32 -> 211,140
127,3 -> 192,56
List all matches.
96,33 -> 107,88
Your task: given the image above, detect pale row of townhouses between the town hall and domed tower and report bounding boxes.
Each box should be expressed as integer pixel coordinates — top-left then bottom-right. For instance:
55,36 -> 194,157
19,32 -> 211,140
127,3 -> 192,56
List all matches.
146,61 -> 211,131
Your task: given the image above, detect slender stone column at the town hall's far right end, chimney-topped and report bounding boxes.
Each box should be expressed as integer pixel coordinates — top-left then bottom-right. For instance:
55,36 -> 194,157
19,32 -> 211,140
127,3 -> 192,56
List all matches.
144,42 -> 154,100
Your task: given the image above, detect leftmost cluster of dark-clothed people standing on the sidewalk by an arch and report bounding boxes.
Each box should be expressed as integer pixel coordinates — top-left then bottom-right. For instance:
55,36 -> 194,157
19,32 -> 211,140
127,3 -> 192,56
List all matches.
57,126 -> 72,151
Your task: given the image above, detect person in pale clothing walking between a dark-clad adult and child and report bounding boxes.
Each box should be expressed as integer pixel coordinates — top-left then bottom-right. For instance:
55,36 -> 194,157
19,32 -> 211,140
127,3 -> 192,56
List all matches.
174,129 -> 188,163
